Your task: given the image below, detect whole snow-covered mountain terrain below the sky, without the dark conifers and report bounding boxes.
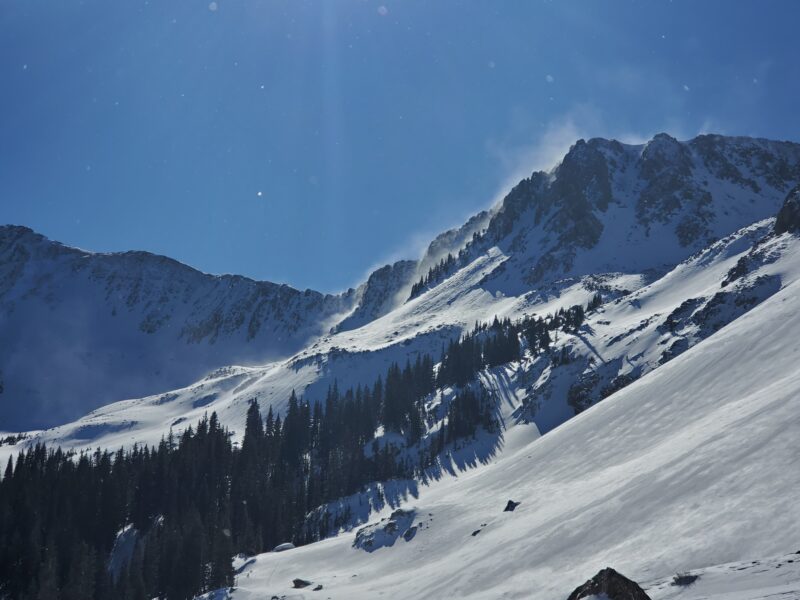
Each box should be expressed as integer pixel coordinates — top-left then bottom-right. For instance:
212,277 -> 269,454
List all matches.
0,134 -> 800,600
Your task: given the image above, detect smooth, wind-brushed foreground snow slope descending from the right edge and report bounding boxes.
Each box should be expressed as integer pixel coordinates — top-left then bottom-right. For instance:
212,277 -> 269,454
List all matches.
222,268 -> 800,600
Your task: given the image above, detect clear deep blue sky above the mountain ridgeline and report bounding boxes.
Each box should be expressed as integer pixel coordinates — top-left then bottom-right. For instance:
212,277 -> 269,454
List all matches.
0,0 -> 800,291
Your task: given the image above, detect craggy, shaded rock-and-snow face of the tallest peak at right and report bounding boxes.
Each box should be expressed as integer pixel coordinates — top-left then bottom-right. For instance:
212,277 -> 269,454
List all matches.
461,134 -> 800,295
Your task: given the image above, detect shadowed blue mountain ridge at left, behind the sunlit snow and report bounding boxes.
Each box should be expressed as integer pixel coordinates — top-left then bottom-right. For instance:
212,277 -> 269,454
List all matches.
0,226 -> 355,430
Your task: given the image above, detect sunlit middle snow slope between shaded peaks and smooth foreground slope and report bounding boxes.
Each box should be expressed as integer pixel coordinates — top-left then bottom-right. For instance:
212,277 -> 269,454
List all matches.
9,213 -> 800,460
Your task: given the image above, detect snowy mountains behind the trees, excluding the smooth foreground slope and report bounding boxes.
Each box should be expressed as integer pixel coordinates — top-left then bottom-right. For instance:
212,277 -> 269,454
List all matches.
0,134 -> 800,447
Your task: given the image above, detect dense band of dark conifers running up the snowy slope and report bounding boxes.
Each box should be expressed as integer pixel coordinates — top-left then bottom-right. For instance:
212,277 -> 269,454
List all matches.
0,296 -> 600,600
